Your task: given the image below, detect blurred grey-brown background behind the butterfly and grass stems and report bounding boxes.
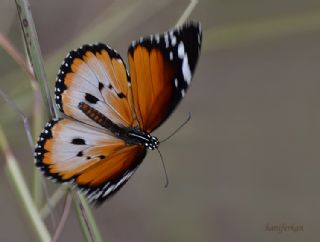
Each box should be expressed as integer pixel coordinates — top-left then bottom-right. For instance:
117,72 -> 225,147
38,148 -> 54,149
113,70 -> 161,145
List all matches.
0,0 -> 320,242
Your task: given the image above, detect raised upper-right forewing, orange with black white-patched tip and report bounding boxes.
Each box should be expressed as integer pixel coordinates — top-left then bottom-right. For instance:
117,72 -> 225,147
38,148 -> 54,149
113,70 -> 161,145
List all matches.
128,22 -> 202,132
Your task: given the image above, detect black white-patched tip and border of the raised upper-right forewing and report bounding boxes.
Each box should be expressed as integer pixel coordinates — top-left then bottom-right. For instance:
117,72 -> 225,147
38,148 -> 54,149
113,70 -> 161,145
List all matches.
128,21 -> 202,116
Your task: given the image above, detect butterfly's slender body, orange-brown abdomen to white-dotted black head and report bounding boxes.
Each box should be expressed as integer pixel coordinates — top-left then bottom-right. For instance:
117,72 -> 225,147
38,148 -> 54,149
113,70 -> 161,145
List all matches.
79,102 -> 159,150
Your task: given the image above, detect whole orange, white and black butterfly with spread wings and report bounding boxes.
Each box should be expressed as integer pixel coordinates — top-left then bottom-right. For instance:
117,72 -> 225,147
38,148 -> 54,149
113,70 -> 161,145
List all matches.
35,22 -> 202,204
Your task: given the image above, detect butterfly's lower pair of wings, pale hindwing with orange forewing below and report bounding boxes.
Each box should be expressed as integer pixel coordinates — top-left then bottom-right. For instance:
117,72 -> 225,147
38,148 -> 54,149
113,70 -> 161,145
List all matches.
35,119 -> 146,205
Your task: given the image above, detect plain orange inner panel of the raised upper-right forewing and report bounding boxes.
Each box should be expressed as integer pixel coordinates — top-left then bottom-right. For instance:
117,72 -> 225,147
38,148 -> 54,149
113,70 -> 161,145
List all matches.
128,46 -> 174,132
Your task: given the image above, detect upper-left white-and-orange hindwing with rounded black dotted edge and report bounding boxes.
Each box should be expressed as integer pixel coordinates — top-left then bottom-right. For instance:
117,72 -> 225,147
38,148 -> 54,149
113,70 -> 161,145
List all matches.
55,44 -> 138,127
